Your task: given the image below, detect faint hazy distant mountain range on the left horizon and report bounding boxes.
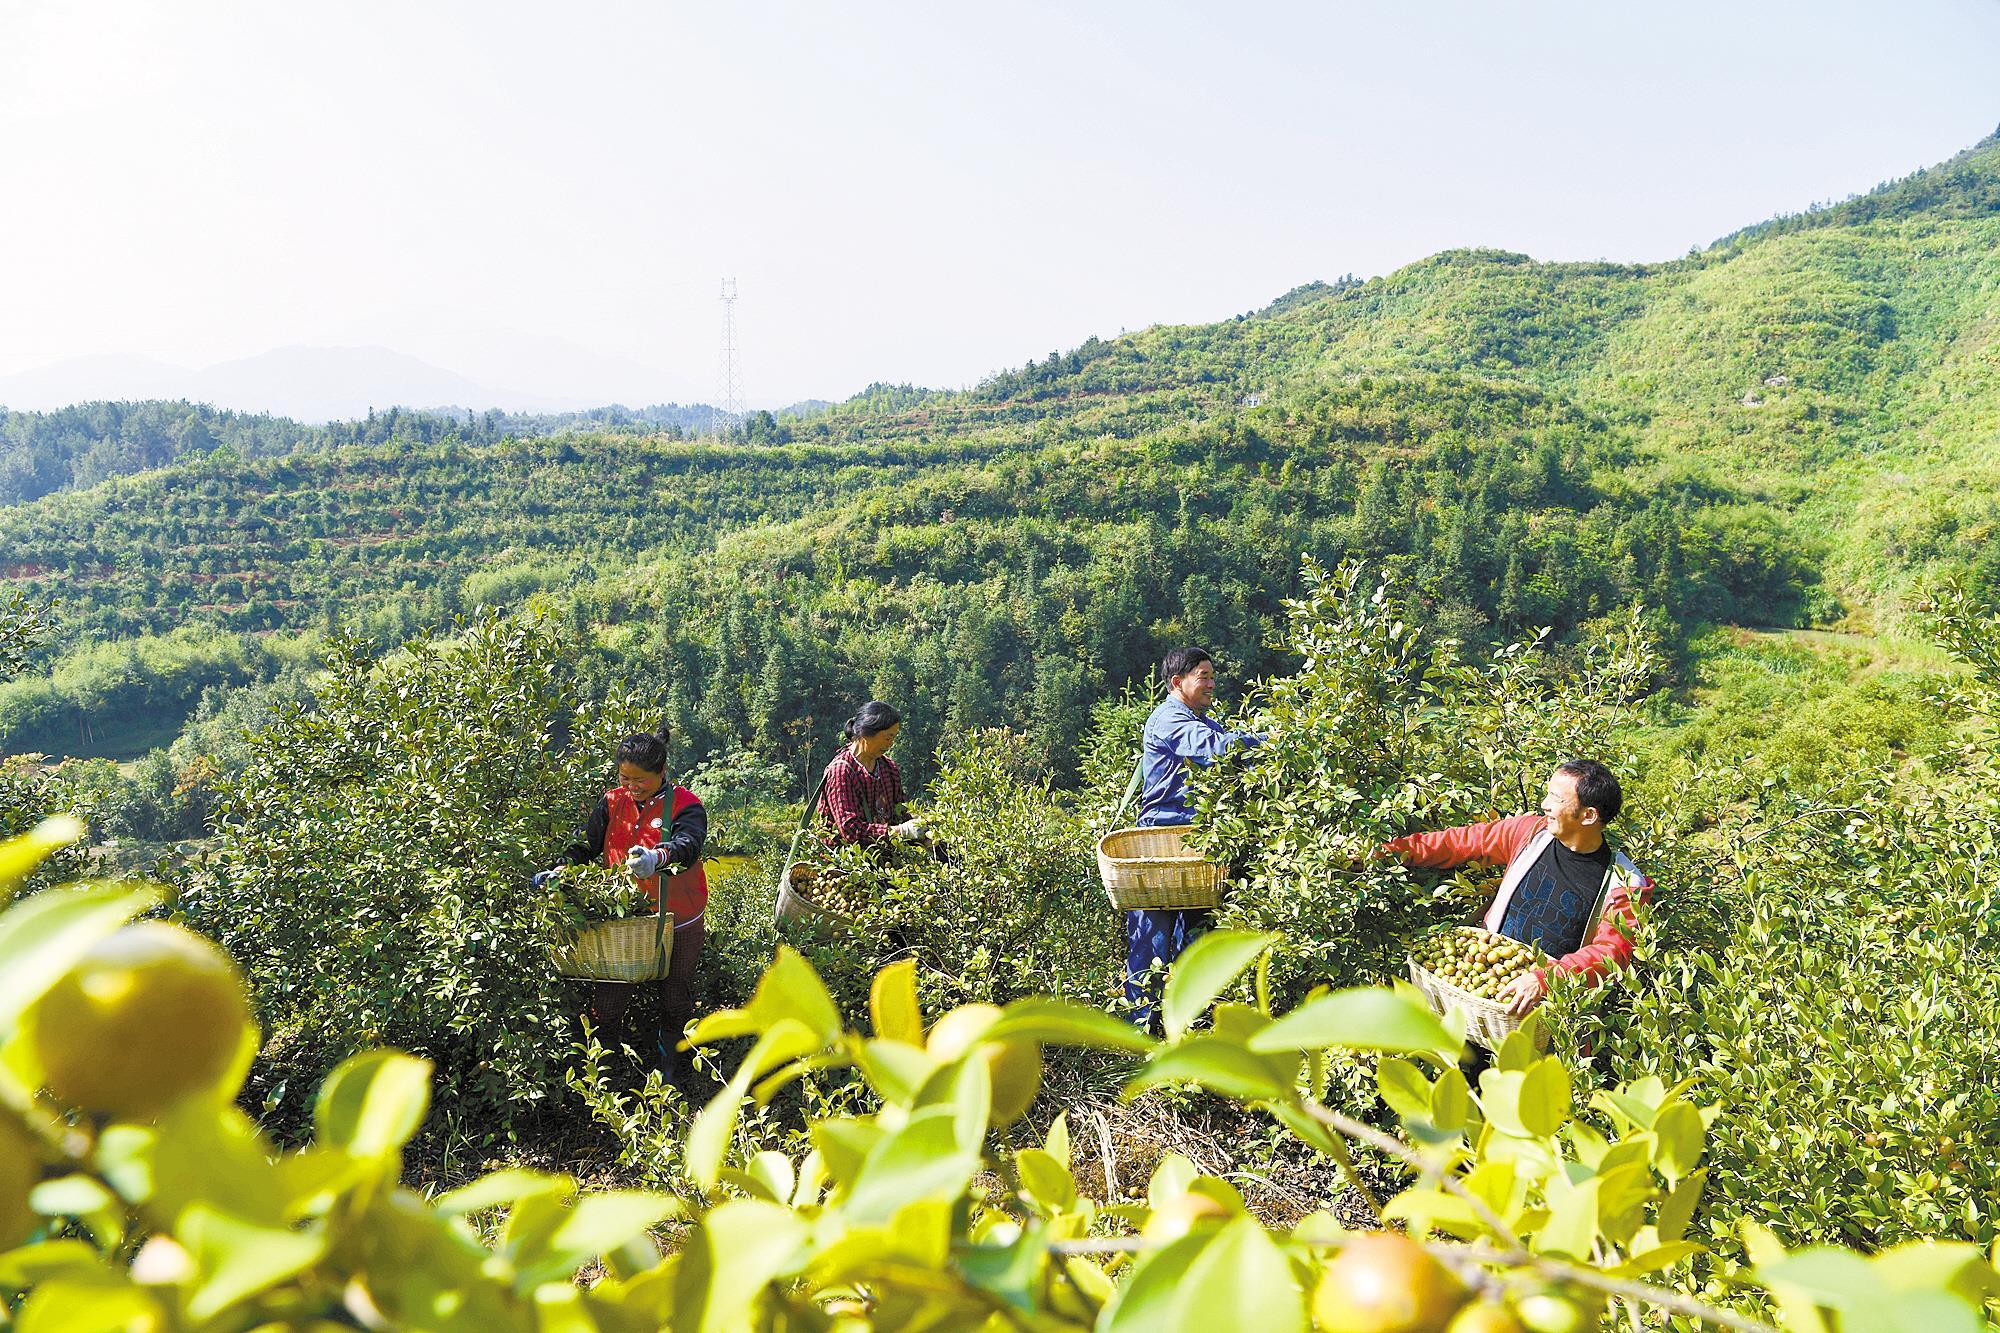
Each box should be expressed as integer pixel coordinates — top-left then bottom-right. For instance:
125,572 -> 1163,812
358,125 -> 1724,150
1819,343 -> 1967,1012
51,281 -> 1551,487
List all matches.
0,338 -> 712,422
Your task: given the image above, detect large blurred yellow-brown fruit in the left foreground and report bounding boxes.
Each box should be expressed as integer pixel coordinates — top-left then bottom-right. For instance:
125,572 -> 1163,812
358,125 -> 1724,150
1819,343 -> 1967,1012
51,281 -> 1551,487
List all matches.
24,921 -> 254,1121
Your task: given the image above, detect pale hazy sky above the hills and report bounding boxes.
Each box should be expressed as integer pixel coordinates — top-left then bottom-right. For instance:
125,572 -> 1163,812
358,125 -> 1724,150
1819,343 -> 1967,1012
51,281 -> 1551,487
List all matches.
0,0 -> 2000,402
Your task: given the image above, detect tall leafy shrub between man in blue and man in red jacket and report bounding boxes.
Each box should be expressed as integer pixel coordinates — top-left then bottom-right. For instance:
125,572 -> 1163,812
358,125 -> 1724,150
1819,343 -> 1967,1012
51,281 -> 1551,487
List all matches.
1192,562 -> 1658,999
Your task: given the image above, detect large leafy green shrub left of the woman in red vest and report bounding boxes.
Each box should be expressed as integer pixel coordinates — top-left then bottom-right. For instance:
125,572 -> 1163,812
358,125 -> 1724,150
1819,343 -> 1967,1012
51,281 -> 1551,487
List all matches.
182,616 -> 658,1135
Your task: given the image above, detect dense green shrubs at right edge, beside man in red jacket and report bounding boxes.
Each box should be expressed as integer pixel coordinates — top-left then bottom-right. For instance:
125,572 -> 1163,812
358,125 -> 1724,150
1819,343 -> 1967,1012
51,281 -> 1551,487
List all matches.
1558,600 -> 2000,1251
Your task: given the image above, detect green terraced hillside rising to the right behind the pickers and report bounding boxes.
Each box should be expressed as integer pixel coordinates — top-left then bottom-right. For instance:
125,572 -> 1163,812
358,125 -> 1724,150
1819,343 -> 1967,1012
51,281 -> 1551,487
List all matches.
0,131 -> 2000,769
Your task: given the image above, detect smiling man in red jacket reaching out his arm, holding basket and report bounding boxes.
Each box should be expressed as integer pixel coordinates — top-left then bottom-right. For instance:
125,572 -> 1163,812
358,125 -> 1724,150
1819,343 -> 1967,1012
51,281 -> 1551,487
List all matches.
1382,759 -> 1652,1013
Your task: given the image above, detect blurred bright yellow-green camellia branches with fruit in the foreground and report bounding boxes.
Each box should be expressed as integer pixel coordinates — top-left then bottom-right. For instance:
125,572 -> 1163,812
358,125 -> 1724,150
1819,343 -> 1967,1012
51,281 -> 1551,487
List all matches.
0,823 -> 2000,1333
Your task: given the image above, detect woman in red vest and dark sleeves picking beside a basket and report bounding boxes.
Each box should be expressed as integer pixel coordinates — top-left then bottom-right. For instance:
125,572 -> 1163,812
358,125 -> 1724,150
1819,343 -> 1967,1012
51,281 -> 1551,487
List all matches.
544,727 -> 708,1077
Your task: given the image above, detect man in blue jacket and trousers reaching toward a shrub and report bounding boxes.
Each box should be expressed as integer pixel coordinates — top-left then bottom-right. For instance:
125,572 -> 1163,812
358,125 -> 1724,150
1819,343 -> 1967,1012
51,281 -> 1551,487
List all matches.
1126,648 -> 1262,1029
